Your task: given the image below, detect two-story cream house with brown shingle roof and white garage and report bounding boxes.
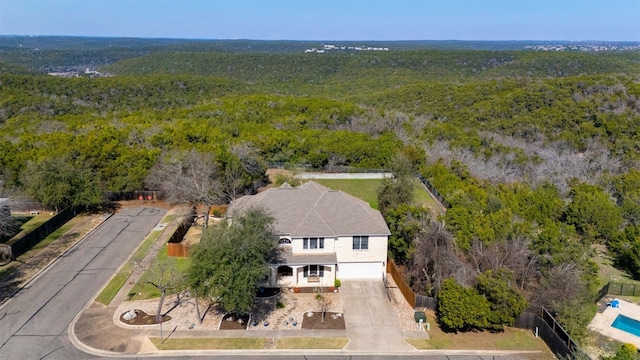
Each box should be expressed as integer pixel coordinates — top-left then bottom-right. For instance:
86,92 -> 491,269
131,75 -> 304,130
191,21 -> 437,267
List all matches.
229,181 -> 390,287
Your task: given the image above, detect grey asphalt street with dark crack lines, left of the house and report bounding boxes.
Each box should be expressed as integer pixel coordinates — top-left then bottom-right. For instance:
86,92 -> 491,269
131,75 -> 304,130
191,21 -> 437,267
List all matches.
0,207 -> 166,359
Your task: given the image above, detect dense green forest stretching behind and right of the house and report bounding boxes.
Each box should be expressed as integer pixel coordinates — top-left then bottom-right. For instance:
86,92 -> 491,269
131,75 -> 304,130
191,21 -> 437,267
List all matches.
0,39 -> 640,346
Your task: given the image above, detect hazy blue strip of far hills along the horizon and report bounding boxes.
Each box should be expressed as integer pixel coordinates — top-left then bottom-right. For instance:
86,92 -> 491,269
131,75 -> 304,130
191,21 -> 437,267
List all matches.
0,36 -> 640,75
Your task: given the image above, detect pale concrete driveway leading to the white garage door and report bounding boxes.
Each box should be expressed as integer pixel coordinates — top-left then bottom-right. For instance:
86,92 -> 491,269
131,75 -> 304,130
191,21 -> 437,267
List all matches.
340,280 -> 415,354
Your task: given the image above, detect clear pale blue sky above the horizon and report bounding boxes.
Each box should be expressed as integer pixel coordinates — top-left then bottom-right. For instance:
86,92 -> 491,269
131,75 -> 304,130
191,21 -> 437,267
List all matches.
0,0 -> 640,41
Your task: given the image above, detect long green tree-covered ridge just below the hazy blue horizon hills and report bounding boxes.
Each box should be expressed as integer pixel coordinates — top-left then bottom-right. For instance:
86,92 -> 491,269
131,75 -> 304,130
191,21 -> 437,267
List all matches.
103,50 -> 640,96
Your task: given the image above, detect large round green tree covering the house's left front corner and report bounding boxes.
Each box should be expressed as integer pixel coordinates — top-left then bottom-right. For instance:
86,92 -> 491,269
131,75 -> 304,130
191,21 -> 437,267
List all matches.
188,208 -> 278,314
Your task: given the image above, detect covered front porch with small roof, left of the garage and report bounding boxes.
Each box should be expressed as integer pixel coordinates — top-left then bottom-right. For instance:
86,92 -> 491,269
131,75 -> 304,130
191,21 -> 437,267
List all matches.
268,253 -> 337,287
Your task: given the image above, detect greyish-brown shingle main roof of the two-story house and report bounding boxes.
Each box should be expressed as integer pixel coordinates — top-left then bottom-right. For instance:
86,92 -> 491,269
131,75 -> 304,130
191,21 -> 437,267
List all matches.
229,181 -> 390,237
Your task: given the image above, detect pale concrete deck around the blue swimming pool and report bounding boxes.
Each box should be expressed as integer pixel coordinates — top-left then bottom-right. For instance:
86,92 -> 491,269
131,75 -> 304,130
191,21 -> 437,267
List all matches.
589,299 -> 640,348
